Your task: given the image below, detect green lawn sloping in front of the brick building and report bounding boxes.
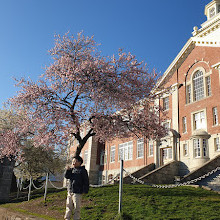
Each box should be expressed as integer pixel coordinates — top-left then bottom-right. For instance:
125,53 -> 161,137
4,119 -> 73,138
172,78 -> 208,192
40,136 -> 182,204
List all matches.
1,185 -> 220,220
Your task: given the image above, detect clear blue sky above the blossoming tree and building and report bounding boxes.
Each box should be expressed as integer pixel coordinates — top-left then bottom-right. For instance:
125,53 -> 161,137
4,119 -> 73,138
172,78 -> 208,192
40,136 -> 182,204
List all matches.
0,0 -> 211,108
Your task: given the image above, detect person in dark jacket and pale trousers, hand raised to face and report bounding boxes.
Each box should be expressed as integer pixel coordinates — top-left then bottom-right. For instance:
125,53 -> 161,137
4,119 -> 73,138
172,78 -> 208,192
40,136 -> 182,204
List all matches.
64,156 -> 89,220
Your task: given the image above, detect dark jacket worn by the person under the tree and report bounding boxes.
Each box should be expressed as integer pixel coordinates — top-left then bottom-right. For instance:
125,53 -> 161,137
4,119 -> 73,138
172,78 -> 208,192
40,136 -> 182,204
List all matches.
65,166 -> 89,194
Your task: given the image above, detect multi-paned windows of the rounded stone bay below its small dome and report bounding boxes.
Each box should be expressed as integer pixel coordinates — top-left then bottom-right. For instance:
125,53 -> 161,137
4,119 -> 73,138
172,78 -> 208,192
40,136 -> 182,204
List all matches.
193,138 -> 208,158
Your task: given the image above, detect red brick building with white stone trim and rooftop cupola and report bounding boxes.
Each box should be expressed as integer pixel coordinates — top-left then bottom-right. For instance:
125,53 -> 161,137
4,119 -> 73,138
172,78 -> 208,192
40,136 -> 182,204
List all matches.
70,0 -> 220,183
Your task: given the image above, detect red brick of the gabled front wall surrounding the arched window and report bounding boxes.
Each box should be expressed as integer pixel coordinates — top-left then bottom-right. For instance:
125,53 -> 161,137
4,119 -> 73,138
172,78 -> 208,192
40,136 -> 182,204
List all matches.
175,47 -> 220,140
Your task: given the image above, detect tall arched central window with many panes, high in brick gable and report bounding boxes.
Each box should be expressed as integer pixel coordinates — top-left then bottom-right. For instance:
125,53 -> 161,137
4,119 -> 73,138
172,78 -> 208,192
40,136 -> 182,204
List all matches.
193,70 -> 204,101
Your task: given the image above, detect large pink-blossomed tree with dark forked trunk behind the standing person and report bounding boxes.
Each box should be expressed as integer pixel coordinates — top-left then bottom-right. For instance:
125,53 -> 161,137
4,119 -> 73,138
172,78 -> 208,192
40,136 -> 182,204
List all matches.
11,33 -> 165,155
